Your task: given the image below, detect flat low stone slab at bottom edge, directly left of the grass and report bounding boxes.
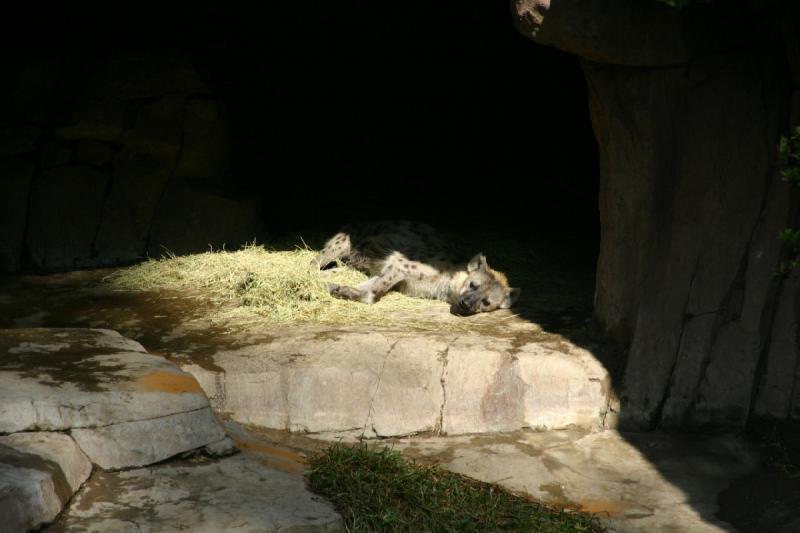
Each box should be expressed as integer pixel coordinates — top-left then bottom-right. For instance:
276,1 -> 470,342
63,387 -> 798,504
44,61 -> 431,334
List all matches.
46,455 -> 342,533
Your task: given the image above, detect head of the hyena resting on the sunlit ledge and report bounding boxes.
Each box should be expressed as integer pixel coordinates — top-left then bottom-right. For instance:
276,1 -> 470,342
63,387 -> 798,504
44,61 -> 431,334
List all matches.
451,254 -> 520,316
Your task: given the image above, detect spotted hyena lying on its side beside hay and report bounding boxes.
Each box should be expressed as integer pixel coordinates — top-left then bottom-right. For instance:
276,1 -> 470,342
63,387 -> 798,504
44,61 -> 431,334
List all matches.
314,221 -> 520,315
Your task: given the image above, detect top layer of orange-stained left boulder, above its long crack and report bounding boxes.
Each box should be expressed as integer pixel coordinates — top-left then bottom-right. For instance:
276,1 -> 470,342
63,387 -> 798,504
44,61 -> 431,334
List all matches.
0,328 -> 208,433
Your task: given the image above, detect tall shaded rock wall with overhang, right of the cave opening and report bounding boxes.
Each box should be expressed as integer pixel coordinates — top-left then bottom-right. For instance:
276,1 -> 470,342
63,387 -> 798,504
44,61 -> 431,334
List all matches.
512,0 -> 800,429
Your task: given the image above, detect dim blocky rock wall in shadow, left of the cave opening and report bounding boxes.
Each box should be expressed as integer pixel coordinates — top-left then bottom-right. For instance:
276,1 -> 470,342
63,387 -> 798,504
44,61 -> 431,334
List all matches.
0,49 -> 260,273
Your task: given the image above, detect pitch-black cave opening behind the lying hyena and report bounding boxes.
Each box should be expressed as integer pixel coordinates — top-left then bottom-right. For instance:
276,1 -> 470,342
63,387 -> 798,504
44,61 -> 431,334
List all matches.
3,1 -> 599,240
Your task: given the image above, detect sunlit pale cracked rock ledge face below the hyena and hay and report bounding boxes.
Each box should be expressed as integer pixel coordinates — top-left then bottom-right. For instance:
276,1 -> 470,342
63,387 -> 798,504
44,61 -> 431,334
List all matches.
183,328 -> 611,436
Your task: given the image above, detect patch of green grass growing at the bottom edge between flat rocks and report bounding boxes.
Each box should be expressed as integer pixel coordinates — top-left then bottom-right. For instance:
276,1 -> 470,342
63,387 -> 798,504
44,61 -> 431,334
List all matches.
309,444 -> 606,533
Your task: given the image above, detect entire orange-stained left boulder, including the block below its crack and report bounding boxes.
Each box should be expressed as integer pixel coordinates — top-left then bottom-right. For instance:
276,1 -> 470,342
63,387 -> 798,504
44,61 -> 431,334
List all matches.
0,329 -> 231,468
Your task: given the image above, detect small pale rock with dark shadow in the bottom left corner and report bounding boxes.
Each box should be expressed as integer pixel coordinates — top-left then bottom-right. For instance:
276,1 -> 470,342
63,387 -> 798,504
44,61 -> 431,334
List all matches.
0,432 -> 92,532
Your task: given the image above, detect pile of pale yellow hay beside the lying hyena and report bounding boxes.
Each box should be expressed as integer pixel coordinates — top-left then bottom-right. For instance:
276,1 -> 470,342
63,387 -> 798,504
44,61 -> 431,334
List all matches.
106,245 -> 468,329
